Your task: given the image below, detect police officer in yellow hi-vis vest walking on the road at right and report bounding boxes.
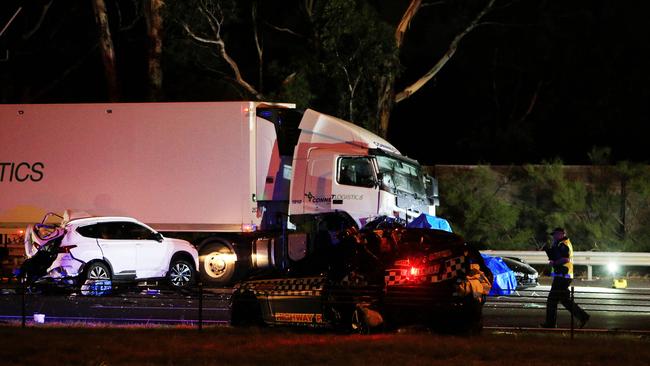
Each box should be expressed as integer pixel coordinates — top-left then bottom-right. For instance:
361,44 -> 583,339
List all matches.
541,227 -> 589,328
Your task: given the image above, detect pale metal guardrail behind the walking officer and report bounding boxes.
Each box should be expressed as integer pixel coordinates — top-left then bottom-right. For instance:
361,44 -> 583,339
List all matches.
481,250 -> 650,280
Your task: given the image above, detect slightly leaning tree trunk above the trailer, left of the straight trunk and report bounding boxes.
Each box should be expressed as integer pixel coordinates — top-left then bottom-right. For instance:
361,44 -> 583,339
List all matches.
93,0 -> 119,102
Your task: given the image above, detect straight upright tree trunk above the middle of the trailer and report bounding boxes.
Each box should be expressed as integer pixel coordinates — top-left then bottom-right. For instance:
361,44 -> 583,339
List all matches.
144,0 -> 165,101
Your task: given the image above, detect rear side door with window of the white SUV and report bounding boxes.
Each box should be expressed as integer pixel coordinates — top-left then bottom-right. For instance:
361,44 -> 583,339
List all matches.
97,222 -> 137,280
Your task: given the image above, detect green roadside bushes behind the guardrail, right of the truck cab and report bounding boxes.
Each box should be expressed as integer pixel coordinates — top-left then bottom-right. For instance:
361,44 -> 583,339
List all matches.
438,160 -> 650,251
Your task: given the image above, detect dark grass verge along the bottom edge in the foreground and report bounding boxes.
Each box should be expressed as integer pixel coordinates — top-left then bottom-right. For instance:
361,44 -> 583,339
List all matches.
0,324 -> 650,366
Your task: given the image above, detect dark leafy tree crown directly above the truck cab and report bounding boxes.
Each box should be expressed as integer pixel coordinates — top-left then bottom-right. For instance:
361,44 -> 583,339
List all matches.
312,0 -> 399,130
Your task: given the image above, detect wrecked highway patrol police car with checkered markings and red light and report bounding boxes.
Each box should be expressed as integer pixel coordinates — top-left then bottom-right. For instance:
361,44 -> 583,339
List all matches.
231,212 -> 492,333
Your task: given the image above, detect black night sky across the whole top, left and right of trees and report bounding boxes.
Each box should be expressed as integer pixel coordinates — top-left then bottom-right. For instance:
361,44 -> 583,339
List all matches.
0,0 -> 650,165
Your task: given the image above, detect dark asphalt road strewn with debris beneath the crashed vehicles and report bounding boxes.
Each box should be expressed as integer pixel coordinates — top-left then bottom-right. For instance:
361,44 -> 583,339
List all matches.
0,281 -> 650,332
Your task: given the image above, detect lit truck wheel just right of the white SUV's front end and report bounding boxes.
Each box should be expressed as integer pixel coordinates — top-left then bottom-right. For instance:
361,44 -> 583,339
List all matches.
199,243 -> 237,285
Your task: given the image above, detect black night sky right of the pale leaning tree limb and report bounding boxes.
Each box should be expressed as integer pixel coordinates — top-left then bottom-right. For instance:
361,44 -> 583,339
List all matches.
390,1 -> 650,164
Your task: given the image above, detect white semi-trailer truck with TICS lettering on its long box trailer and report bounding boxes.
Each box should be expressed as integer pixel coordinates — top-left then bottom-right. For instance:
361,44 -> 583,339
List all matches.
0,102 -> 437,284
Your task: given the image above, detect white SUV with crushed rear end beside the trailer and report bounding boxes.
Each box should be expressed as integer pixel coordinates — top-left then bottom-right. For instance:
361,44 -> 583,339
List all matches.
18,211 -> 198,294
